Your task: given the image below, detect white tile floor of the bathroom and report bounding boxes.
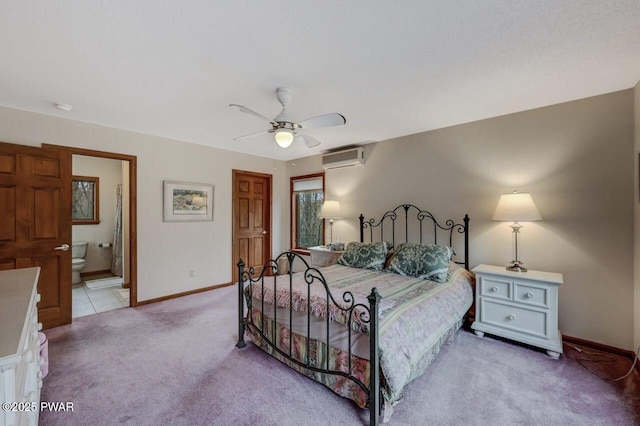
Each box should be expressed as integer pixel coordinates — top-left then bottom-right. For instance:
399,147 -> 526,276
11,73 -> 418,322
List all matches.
71,282 -> 129,318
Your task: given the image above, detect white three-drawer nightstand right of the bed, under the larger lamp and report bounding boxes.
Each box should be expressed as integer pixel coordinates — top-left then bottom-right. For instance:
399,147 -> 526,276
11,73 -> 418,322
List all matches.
471,265 -> 562,359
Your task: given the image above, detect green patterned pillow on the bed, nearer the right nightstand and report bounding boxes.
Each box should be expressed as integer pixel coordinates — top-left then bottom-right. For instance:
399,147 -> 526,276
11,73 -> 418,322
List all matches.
388,243 -> 455,283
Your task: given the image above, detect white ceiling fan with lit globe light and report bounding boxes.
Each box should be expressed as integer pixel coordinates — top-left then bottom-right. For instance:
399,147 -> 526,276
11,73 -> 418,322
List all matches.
229,87 -> 347,148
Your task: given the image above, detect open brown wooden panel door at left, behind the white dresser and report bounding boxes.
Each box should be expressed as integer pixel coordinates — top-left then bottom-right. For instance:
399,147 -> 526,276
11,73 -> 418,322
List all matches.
0,143 -> 71,328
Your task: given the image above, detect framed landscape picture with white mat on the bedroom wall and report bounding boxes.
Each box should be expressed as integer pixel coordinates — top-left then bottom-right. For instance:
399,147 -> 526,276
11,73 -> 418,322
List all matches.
163,180 -> 213,222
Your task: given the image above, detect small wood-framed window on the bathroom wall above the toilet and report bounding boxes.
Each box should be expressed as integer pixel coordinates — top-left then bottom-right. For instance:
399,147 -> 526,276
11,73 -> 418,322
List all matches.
71,176 -> 100,225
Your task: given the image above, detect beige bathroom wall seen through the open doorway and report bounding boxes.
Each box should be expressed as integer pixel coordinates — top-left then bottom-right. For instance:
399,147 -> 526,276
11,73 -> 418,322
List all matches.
72,155 -> 122,273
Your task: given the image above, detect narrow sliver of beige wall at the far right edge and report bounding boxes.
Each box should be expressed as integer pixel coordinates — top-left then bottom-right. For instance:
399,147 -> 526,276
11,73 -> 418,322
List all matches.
633,81 -> 640,350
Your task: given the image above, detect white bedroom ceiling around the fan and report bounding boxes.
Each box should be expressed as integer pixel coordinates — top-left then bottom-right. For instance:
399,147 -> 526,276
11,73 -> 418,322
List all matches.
0,0 -> 640,160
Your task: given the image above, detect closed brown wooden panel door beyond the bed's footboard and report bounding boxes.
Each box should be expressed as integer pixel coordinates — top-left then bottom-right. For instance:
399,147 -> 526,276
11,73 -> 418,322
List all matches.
233,170 -> 272,282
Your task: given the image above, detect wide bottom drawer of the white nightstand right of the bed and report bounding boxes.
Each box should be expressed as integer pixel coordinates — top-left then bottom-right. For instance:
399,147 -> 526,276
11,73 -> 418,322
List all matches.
480,299 -> 549,337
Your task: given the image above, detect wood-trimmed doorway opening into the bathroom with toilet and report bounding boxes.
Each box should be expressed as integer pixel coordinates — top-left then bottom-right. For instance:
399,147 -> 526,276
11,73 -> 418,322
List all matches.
47,145 -> 137,319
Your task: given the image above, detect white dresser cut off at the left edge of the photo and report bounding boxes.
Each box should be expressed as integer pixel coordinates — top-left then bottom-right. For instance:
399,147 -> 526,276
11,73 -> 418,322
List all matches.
0,268 -> 42,426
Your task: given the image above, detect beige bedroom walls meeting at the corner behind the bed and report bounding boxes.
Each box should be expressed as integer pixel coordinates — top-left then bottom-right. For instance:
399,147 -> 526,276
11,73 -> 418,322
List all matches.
0,86 -> 640,349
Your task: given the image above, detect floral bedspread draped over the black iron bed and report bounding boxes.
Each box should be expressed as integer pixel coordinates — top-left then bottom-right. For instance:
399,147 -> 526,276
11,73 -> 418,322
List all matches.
245,263 -> 473,405
